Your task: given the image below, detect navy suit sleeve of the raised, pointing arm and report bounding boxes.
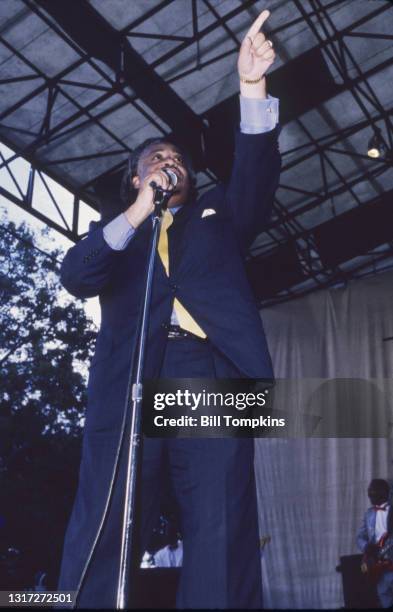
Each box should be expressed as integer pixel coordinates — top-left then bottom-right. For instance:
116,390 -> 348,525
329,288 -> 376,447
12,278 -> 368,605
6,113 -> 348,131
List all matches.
225,126 -> 281,248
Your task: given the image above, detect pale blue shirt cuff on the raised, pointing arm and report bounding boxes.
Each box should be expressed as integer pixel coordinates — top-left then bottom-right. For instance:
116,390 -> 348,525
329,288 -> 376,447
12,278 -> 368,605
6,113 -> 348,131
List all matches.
240,96 -> 279,134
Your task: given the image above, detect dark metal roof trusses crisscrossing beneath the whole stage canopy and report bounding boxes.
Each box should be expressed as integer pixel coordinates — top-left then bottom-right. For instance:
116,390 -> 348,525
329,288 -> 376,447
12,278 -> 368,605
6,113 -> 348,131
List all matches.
0,0 -> 393,305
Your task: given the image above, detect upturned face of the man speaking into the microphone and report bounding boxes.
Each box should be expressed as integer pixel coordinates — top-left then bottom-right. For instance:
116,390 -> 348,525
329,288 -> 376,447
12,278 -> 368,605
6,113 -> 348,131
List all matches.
132,142 -> 190,208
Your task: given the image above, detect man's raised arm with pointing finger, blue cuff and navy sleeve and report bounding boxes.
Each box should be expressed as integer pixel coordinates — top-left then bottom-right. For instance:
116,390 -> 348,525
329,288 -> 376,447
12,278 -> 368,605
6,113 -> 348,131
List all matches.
226,10 -> 281,248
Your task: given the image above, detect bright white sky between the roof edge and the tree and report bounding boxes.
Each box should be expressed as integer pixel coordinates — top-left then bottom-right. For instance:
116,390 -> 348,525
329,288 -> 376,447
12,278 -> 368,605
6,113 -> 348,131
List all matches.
0,143 -> 101,327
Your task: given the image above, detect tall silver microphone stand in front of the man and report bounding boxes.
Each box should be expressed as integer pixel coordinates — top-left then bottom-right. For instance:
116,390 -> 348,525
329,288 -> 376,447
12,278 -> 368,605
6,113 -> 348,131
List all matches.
116,183 -> 173,610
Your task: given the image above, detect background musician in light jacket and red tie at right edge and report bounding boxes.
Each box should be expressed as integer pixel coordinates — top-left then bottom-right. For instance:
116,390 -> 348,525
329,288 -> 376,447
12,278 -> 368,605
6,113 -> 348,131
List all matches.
357,478 -> 393,608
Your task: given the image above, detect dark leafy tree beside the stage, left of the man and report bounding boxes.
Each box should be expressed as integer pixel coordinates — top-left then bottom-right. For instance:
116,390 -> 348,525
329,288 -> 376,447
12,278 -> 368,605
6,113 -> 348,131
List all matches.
0,210 -> 96,588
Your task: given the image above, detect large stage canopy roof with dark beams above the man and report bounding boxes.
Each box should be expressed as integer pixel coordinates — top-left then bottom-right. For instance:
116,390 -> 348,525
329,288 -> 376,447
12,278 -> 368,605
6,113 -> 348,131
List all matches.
0,0 -> 393,305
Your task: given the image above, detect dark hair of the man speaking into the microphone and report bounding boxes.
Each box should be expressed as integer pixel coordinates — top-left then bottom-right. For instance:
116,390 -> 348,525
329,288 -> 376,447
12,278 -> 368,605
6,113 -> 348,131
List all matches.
120,137 -> 196,207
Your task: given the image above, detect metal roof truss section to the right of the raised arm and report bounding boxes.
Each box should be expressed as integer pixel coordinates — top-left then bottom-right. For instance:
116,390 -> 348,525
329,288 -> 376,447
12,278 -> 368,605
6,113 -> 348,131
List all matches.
264,0 -> 393,306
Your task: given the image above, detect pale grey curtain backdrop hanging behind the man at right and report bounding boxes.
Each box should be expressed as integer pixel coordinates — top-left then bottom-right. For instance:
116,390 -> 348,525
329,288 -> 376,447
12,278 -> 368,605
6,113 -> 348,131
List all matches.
255,273 -> 393,609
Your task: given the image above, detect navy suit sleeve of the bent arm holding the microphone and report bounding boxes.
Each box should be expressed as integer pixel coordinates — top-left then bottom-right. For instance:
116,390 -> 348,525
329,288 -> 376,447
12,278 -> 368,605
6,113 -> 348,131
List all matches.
60,222 -> 121,298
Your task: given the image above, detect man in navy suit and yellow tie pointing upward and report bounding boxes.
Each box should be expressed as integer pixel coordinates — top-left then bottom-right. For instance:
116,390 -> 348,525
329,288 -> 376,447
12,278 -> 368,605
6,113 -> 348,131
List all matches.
59,11 -> 280,609
